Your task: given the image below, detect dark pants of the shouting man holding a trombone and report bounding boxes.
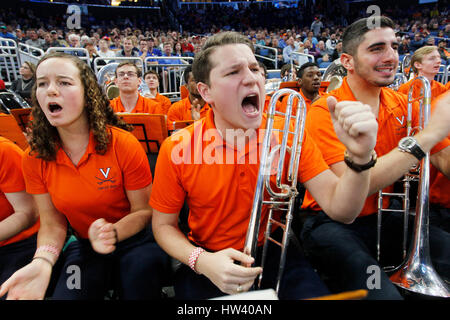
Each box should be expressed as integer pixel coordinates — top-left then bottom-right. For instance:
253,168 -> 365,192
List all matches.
175,230 -> 329,300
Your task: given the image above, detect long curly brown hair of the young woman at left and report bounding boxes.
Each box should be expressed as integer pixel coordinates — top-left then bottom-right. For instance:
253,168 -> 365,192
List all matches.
29,52 -> 133,161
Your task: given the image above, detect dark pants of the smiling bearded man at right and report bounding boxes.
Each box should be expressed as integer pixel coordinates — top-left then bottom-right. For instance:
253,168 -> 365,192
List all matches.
301,208 -> 450,300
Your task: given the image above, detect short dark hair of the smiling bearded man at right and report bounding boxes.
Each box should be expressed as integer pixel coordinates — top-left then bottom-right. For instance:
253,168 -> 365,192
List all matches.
342,16 -> 395,56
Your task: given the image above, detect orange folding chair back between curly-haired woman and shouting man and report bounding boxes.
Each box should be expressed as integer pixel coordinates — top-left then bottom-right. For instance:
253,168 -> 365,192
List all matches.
119,113 -> 168,155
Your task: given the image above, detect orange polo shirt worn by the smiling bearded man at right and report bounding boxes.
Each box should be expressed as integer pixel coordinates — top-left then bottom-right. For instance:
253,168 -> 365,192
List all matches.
302,77 -> 450,216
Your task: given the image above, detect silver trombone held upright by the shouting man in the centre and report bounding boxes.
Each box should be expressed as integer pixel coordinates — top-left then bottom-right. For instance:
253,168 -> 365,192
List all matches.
244,89 -> 306,294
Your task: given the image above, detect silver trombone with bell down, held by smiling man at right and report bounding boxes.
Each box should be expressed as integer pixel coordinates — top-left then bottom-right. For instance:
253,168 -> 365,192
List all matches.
377,76 -> 450,297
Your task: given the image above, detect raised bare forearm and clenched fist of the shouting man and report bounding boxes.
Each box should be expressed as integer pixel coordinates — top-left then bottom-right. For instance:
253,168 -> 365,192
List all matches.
305,97 -> 378,223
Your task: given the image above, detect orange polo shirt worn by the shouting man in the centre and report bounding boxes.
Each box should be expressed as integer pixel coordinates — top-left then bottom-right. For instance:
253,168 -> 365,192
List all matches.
150,110 -> 328,251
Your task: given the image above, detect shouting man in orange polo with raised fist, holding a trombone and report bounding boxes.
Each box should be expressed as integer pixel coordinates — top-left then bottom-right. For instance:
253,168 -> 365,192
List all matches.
150,32 -> 377,299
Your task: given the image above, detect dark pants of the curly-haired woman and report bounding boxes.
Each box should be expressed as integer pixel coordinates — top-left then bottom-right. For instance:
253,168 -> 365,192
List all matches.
52,227 -> 170,300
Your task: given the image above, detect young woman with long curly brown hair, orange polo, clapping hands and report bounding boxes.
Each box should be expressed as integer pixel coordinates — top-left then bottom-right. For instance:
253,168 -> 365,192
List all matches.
0,53 -> 168,299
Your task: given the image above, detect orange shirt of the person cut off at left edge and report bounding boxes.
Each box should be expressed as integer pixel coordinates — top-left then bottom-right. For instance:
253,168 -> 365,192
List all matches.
0,137 -> 39,247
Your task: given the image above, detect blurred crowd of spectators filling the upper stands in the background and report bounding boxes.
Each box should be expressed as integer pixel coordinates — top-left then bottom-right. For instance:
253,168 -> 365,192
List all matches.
0,1 -> 450,69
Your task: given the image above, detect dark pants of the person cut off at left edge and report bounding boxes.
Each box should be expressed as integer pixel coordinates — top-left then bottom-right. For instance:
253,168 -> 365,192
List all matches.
0,235 -> 36,300
